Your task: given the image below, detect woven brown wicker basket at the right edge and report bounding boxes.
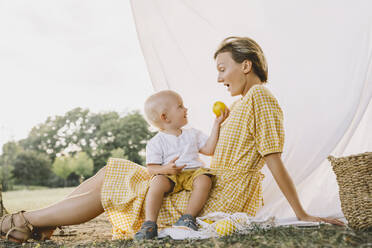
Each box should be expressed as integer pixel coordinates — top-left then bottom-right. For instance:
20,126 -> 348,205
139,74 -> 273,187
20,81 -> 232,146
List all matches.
328,152 -> 372,230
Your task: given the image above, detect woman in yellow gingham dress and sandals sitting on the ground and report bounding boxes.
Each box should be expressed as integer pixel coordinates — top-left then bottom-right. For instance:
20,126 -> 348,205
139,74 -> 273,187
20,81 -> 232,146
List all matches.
0,37 -> 343,241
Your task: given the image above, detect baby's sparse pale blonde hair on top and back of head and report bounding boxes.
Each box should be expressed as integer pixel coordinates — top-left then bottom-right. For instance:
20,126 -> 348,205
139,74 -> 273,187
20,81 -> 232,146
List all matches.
145,90 -> 181,129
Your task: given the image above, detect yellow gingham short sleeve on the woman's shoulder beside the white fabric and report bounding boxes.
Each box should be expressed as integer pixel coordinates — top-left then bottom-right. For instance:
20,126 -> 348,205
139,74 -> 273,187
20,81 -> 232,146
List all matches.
247,86 -> 284,156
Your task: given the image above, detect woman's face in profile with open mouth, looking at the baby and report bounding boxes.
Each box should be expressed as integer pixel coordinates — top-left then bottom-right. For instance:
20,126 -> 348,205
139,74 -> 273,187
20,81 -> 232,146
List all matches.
216,52 -> 247,96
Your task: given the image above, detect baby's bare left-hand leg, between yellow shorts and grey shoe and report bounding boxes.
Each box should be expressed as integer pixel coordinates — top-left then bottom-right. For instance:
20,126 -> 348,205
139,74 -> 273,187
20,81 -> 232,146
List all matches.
145,175 -> 174,222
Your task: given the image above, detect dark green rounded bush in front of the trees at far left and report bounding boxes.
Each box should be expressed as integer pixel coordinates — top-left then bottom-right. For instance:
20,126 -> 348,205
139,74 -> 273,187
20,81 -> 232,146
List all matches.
13,151 -> 52,186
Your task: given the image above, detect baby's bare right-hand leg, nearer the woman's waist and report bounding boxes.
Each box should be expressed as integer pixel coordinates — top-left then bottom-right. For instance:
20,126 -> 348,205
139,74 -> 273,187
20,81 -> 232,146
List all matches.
185,174 -> 212,217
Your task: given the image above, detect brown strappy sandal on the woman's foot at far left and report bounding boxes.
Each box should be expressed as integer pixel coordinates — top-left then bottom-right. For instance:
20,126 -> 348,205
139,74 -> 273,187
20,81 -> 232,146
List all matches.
0,210 -> 34,243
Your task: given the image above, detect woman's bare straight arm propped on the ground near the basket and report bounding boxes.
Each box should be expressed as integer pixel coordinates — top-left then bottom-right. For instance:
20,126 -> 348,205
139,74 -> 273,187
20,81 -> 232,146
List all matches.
264,153 -> 344,226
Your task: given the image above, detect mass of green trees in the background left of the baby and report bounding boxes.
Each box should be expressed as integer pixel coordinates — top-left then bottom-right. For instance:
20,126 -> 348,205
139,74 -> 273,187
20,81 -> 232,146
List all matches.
0,108 -> 154,187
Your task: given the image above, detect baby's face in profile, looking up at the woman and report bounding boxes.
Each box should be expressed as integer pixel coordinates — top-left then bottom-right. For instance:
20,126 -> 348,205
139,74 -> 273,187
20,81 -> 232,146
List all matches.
166,94 -> 187,128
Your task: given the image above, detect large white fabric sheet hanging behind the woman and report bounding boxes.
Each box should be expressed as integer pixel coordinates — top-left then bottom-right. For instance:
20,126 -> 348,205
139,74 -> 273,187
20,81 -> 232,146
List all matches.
131,0 -> 372,217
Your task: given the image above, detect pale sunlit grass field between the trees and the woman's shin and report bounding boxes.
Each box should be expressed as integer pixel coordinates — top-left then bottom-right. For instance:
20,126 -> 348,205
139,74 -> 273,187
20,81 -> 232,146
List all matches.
3,187 -> 74,213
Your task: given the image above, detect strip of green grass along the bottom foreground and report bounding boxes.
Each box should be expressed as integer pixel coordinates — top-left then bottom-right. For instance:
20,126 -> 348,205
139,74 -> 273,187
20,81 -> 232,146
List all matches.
2,225 -> 372,248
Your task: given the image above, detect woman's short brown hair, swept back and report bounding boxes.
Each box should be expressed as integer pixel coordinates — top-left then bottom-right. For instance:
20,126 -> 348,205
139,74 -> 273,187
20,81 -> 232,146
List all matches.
214,36 -> 268,82
